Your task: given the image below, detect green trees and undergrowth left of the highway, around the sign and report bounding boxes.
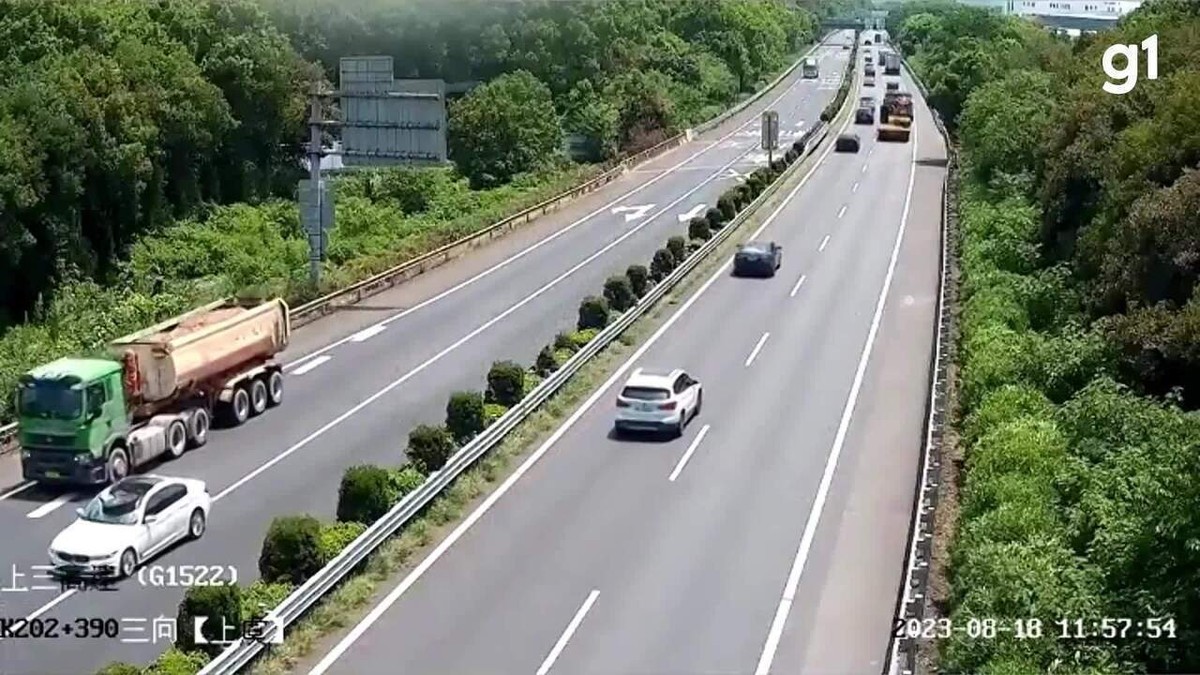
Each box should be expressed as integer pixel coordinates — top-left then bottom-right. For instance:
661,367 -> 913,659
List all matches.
0,0 -> 823,418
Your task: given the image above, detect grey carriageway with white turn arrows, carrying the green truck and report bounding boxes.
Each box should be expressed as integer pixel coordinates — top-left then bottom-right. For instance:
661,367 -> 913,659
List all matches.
0,34 -> 848,675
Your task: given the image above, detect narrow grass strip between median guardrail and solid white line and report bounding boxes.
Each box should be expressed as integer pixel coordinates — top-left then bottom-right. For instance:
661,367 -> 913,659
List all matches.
251,76 -> 852,675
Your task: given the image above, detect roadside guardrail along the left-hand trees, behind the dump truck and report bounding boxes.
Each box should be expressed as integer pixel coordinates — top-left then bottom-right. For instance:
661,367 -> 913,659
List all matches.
0,42 -> 832,454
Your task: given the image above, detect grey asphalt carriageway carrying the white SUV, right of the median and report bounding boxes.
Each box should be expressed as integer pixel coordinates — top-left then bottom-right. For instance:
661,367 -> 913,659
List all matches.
306,43 -> 946,675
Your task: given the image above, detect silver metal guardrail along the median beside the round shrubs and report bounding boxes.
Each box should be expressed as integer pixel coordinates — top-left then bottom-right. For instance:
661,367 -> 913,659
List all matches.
198,86 -> 852,675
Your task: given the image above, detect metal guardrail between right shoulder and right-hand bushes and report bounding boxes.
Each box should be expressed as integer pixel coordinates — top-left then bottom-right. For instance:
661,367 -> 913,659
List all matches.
883,59 -> 958,675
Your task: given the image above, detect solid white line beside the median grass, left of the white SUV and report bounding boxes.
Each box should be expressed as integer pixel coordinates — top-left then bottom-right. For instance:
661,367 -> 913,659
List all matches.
308,86 -> 850,675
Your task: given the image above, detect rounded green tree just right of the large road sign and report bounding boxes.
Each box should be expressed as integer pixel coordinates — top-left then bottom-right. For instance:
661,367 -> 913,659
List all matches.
449,71 -> 563,187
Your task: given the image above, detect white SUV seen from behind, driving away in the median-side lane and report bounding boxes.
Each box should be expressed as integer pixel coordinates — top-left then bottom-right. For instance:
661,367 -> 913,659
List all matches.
614,368 -> 703,436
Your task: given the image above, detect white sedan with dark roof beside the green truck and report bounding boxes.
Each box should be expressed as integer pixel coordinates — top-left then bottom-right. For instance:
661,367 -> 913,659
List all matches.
49,474 -> 212,579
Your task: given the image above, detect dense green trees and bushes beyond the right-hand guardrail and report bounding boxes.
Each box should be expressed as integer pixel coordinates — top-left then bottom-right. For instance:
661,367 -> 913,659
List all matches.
889,0 -> 1200,675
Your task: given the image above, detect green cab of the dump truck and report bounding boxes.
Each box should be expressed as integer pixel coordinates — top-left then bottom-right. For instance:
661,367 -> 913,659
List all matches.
16,358 -> 130,485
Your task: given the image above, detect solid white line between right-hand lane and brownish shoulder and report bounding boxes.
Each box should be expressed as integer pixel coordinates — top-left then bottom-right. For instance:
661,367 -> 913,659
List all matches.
755,118 -> 917,675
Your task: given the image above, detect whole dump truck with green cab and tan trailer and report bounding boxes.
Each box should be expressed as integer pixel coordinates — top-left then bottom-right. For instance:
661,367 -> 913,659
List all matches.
16,299 -> 292,485
